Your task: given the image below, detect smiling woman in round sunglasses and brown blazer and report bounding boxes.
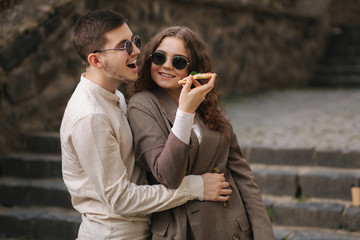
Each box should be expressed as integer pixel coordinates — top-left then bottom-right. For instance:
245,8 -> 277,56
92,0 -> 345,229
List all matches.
128,27 -> 275,239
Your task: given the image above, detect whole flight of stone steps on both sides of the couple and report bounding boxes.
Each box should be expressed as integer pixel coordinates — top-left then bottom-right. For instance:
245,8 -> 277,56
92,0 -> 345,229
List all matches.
0,133 -> 360,239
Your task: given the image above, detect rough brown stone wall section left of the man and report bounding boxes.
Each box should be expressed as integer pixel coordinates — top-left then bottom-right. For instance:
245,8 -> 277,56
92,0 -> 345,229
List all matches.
0,0 -> 81,155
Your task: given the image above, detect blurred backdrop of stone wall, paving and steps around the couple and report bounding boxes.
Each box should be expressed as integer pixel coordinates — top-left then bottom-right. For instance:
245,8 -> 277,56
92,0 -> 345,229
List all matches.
0,0 -> 360,239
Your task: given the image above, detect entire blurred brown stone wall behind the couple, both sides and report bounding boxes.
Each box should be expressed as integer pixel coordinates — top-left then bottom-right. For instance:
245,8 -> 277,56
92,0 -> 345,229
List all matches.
0,0 -> 328,156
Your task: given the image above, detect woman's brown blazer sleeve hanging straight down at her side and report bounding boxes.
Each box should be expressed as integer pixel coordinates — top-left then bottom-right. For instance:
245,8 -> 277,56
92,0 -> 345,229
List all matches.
227,126 -> 275,240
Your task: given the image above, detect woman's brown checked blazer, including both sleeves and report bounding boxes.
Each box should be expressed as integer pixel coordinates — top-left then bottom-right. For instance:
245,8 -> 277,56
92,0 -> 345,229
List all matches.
128,89 -> 275,240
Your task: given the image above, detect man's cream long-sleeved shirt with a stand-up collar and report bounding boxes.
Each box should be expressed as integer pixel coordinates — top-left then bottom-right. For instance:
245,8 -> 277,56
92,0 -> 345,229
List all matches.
60,74 -> 204,240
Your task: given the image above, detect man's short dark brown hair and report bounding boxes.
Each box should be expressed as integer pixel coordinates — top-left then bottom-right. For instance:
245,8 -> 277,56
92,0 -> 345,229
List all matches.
70,10 -> 127,66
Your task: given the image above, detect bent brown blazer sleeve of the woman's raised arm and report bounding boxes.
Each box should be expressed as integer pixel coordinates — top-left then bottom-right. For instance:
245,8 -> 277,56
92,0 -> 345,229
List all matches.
128,98 -> 191,189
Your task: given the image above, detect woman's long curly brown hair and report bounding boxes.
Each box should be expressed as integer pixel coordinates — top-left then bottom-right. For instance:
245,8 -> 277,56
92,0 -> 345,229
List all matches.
130,26 -> 230,132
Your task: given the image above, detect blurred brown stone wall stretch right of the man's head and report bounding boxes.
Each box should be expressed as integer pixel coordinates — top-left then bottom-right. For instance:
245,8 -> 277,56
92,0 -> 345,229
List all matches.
100,0 -> 327,94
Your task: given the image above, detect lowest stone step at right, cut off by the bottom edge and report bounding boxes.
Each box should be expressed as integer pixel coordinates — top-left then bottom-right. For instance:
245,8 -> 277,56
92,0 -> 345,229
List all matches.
274,225 -> 360,240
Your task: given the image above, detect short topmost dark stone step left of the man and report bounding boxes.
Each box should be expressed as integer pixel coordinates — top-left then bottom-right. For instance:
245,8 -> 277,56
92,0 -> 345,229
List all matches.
22,132 -> 61,154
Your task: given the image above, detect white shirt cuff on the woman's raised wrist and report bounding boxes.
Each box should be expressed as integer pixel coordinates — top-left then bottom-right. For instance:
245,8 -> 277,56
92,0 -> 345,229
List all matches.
171,109 -> 195,144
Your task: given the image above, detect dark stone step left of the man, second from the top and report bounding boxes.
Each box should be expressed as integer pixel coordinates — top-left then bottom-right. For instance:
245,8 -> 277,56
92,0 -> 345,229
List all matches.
2,153 -> 62,178
